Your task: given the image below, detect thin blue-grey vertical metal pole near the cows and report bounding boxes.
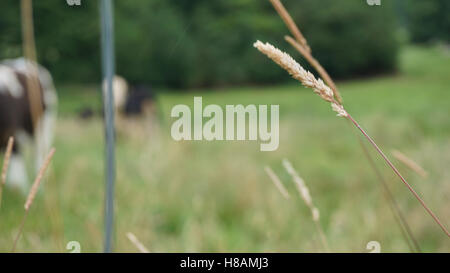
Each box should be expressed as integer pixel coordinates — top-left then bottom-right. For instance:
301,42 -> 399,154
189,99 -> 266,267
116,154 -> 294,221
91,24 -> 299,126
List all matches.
100,0 -> 116,253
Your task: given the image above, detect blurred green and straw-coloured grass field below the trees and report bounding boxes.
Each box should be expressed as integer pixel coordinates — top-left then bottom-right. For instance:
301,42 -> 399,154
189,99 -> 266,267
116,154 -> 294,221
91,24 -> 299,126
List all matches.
0,47 -> 450,252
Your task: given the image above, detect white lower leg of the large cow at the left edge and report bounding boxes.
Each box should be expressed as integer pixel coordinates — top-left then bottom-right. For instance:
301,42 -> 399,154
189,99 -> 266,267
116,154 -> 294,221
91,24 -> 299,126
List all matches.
6,153 -> 28,193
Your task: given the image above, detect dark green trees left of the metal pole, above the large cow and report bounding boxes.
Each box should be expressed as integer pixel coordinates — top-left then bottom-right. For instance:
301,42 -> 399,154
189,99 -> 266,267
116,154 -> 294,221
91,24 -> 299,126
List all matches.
0,0 -> 101,82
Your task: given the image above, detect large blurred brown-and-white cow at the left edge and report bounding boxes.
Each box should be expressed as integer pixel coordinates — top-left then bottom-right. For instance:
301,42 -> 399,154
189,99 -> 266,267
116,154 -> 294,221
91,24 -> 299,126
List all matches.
0,58 -> 57,190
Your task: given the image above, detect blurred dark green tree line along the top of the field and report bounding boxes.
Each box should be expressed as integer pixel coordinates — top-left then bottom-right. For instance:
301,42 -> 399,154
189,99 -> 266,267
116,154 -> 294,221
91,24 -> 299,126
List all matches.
0,0 -> 449,88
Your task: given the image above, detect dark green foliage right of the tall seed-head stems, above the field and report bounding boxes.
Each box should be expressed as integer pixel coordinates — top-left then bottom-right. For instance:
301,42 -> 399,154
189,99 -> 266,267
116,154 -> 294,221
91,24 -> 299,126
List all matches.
286,0 -> 398,78
